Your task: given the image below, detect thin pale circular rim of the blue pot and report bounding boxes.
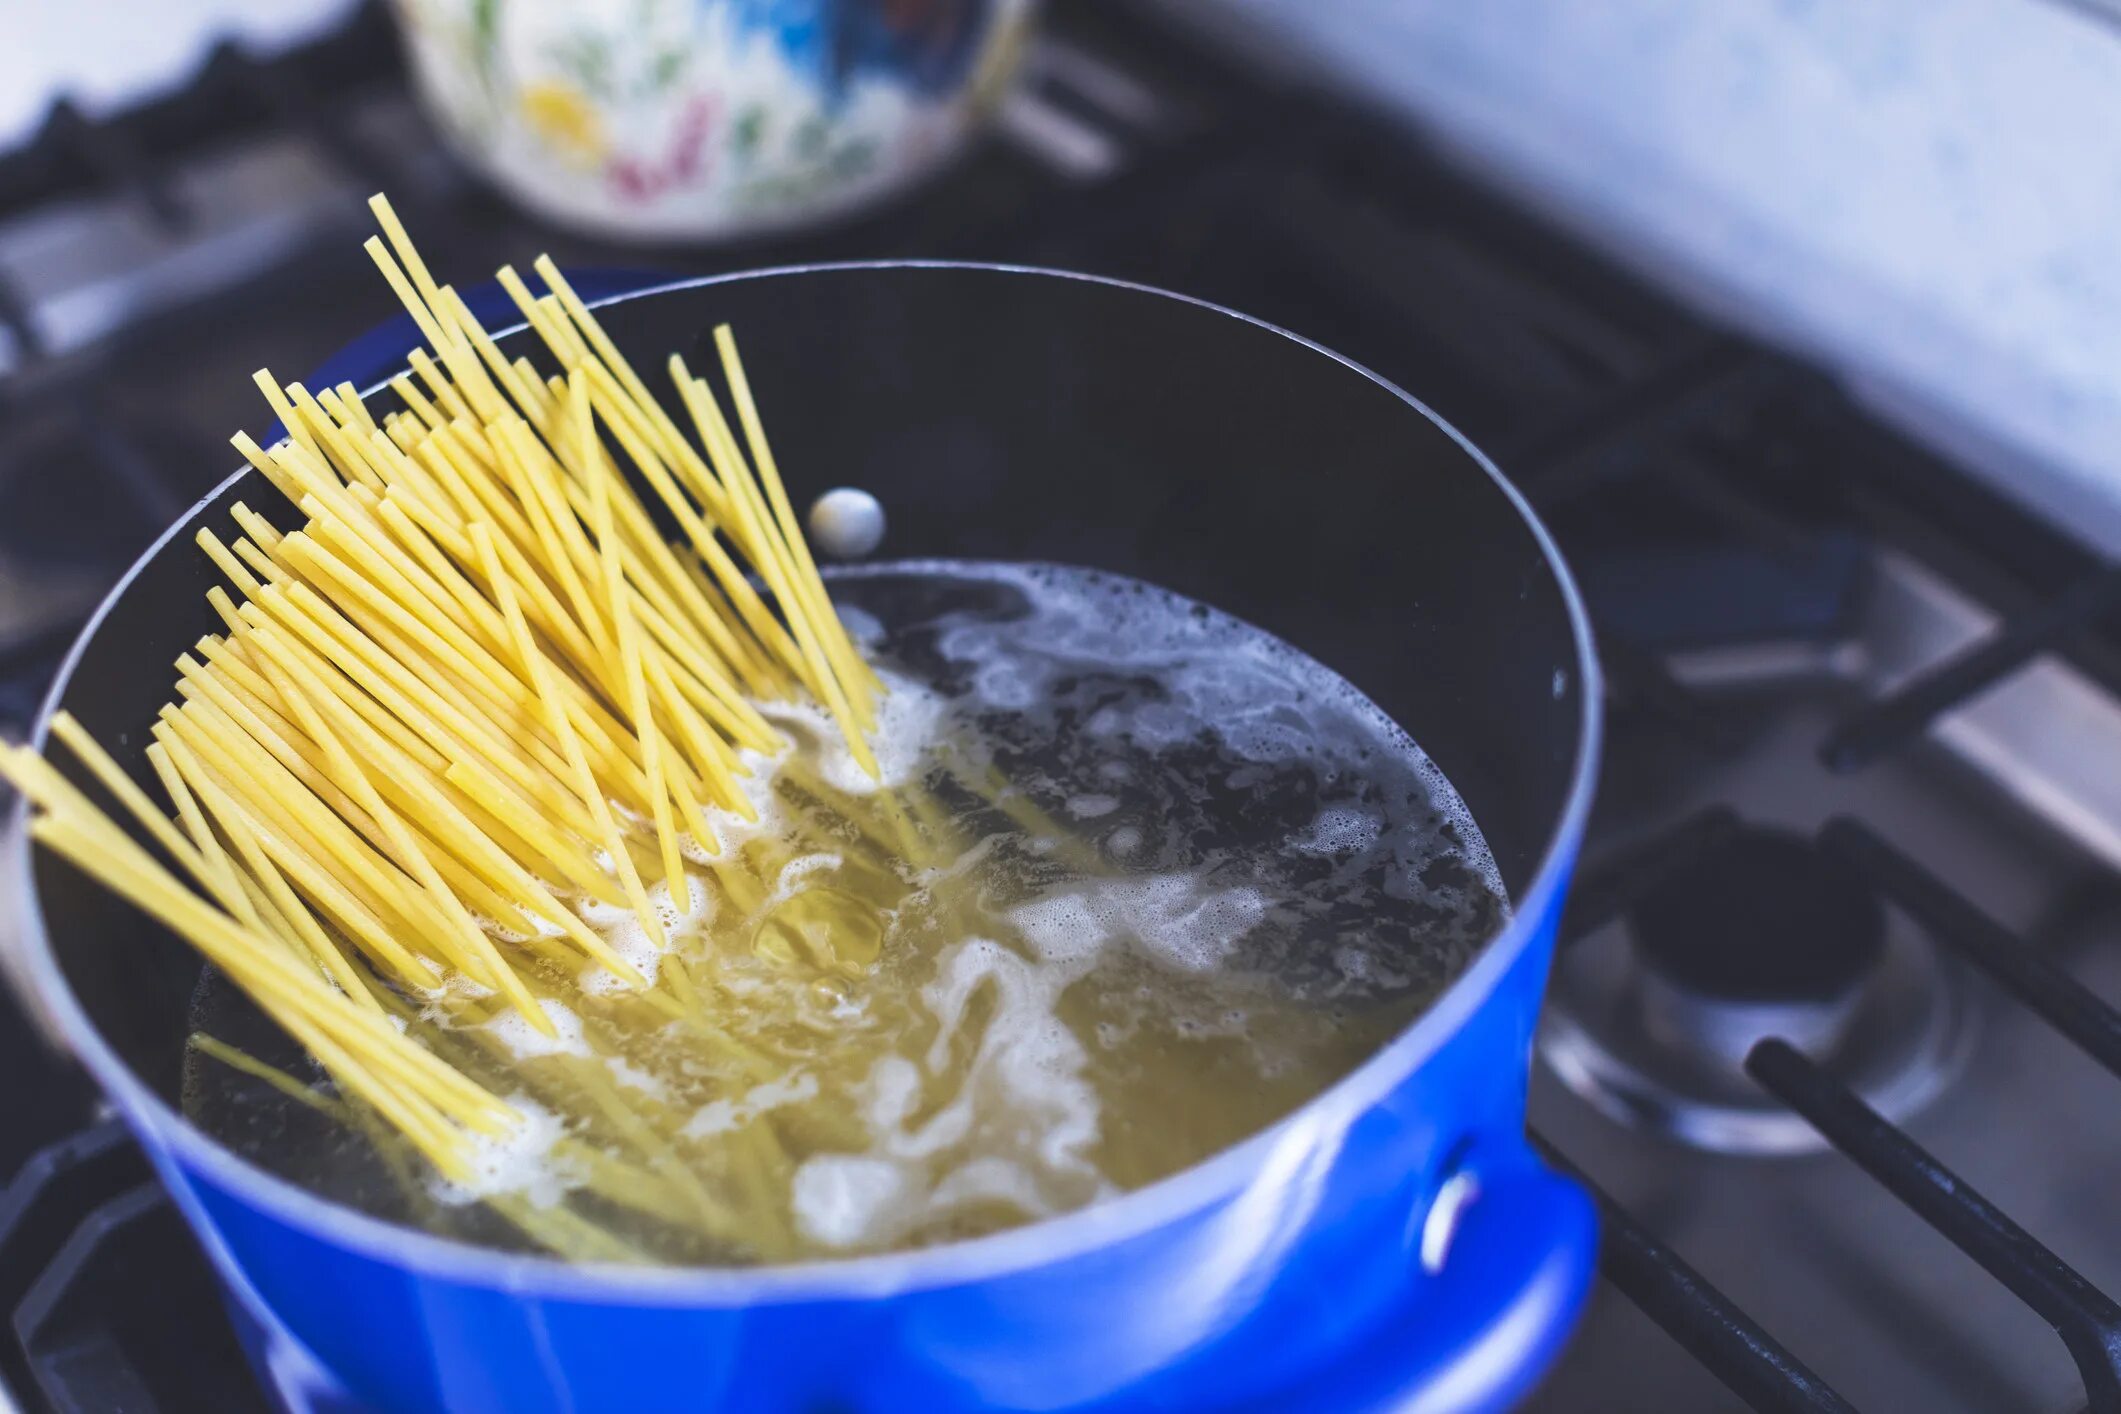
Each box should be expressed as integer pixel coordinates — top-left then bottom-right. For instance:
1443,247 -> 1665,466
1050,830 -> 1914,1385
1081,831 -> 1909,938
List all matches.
0,261 -> 1603,1308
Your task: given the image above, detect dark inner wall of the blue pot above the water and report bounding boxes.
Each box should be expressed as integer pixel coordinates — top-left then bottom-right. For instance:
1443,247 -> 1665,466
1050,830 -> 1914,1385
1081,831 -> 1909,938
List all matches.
34,267 -> 1584,1102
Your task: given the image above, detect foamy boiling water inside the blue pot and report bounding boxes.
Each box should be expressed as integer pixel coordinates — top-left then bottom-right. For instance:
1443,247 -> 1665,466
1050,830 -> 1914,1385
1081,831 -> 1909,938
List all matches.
187,564 -> 1504,1263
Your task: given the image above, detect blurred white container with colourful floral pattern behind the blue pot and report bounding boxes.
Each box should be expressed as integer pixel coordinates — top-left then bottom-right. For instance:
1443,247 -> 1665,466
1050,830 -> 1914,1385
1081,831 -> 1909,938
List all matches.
397,0 -> 1037,242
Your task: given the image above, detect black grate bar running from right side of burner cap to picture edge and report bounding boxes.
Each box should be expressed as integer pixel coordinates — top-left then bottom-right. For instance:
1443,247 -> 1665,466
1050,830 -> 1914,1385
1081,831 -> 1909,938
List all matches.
1820,818 -> 2121,1075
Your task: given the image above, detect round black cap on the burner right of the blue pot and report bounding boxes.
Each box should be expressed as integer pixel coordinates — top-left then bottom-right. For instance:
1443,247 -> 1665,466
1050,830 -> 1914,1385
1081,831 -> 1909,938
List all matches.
1629,827 -> 1886,1005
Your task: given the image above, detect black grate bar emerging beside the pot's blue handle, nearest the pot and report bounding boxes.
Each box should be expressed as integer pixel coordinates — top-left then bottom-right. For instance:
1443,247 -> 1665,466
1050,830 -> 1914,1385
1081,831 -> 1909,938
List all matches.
1531,1134 -> 1856,1414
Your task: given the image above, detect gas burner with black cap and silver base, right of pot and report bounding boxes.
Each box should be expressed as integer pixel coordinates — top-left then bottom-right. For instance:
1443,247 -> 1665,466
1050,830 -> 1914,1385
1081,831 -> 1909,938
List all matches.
1540,827 -> 1966,1153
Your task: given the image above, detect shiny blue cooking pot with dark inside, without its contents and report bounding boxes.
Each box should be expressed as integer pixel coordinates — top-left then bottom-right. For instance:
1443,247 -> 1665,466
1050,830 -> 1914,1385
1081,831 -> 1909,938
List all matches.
8,263 -> 1599,1414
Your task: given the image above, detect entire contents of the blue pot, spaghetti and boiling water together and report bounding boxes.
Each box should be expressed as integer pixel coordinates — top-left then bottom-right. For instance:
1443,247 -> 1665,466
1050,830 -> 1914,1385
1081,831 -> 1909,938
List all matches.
0,197 -> 1502,1261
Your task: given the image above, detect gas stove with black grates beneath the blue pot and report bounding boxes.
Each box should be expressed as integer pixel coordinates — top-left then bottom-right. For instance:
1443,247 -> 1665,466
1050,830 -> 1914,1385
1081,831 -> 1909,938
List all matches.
0,0 -> 2121,1412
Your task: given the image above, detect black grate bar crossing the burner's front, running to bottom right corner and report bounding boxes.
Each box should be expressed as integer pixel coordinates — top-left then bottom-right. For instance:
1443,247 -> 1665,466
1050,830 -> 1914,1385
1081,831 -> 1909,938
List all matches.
1746,1039 -> 2121,1414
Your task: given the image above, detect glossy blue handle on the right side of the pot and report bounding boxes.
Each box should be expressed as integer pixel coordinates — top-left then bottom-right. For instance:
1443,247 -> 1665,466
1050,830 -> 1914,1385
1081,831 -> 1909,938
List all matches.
1262,1134 -> 1597,1414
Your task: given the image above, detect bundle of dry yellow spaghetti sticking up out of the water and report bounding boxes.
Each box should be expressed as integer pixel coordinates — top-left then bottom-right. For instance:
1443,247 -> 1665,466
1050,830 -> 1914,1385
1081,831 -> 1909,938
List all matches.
0,197 -> 886,1210
